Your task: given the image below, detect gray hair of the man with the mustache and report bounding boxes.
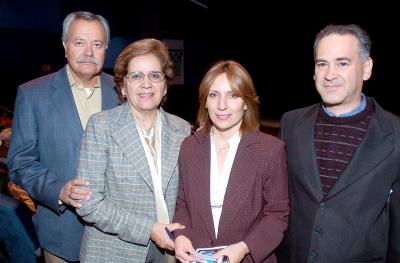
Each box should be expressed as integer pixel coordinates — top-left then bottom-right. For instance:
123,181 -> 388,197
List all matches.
62,11 -> 110,48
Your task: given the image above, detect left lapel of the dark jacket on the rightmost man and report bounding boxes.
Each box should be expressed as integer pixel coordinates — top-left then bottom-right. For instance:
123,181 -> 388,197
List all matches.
294,104 -> 323,200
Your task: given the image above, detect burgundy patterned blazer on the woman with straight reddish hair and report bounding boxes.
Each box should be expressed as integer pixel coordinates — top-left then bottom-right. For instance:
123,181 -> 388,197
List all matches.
174,130 -> 289,262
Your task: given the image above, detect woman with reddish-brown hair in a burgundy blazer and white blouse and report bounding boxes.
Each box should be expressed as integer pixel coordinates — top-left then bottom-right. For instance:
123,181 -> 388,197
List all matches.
173,60 -> 289,263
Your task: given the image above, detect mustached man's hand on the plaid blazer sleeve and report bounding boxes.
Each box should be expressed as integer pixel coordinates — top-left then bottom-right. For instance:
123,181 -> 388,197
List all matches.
58,179 -> 92,208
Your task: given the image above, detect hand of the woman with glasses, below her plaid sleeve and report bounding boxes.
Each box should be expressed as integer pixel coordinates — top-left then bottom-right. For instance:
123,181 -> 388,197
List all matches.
150,223 -> 185,251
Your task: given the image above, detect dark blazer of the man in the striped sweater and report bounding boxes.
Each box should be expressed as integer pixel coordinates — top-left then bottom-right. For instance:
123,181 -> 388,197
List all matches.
280,99 -> 400,263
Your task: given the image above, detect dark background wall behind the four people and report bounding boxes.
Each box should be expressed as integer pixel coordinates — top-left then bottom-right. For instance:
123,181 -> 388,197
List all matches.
0,0 -> 400,125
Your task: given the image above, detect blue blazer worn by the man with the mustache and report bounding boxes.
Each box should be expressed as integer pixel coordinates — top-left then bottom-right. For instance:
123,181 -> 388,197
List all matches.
8,67 -> 118,261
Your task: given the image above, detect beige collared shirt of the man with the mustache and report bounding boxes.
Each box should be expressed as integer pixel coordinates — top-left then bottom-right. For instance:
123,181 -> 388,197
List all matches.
67,65 -> 101,130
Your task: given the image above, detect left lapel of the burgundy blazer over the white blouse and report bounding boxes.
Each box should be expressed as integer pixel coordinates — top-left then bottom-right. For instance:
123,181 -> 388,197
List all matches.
191,133 -> 216,240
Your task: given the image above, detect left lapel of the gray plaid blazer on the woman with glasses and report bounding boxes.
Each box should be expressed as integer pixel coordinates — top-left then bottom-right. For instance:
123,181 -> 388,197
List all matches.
111,102 -> 154,191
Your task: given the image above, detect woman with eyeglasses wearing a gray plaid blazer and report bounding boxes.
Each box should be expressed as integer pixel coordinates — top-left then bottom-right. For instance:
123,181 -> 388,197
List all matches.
77,39 -> 190,263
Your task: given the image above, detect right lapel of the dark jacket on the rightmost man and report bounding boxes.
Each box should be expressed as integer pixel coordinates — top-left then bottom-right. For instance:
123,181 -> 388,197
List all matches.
326,103 -> 394,199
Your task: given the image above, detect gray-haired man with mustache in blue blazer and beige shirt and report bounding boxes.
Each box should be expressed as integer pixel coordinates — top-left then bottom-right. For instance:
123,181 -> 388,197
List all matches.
8,11 -> 118,262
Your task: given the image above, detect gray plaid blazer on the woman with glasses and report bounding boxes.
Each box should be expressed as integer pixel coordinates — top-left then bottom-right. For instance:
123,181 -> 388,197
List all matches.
77,103 -> 190,263
